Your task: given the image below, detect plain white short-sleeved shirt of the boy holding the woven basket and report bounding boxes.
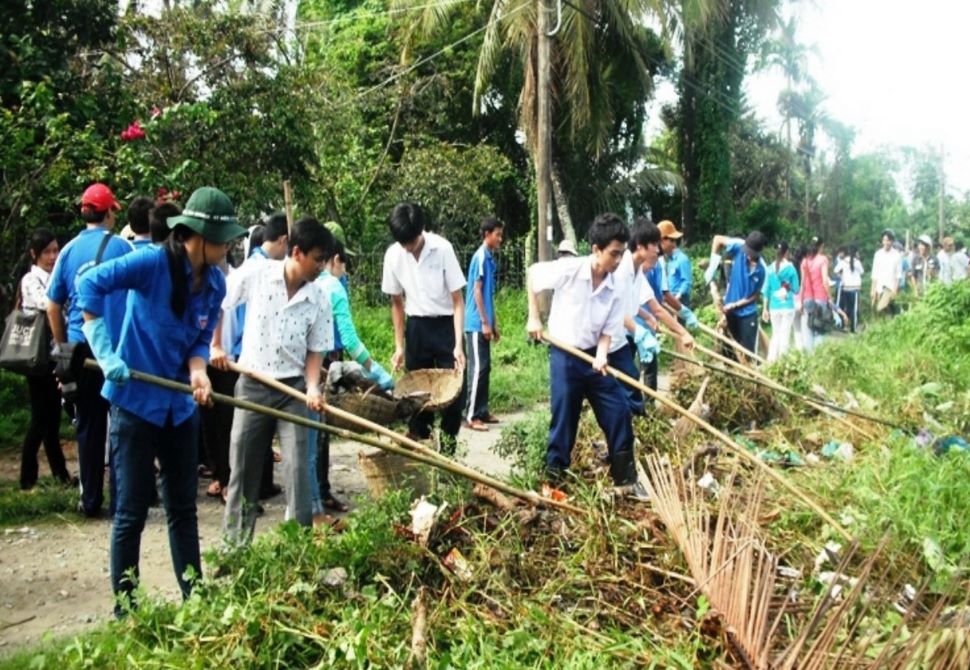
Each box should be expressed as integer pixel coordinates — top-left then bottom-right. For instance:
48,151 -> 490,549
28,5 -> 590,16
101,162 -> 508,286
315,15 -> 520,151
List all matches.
381,231 -> 466,316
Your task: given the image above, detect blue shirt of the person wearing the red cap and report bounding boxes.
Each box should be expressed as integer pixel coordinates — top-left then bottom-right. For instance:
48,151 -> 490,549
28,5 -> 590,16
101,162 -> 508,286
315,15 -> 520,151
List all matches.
47,227 -> 131,346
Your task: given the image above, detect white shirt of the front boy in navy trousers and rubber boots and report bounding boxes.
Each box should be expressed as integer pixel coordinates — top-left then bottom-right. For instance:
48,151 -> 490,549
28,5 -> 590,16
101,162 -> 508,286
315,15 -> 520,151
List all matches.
529,256 -> 626,349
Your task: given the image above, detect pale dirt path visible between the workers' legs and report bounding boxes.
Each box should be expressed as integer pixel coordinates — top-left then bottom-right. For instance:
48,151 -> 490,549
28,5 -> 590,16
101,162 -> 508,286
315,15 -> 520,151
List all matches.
0,414 -> 524,655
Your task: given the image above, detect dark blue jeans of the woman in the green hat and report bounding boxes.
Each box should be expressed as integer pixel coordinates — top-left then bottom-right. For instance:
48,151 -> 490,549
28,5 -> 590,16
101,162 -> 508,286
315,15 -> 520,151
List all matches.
111,405 -> 202,615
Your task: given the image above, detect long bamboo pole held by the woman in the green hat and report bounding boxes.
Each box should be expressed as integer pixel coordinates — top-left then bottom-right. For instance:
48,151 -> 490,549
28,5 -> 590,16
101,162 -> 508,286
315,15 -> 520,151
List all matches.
84,359 -> 585,514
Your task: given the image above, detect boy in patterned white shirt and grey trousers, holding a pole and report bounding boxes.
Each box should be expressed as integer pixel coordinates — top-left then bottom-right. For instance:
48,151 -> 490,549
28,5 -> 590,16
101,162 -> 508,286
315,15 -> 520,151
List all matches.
211,217 -> 334,546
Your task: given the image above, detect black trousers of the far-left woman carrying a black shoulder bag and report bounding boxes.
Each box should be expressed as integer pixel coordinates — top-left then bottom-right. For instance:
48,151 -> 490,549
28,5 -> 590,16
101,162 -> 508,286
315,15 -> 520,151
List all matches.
20,374 -> 71,489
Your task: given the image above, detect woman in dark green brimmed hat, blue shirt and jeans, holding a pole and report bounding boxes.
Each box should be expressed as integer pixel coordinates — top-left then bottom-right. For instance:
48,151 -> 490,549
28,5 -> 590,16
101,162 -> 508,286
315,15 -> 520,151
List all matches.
78,187 -> 245,616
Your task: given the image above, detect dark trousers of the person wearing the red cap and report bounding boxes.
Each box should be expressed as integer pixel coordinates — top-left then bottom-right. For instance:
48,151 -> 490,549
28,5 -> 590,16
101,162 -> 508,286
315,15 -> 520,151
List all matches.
74,369 -> 111,516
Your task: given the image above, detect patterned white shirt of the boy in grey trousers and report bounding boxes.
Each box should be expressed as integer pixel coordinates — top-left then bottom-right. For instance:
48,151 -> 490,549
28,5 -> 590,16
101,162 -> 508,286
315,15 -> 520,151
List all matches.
222,260 -> 333,379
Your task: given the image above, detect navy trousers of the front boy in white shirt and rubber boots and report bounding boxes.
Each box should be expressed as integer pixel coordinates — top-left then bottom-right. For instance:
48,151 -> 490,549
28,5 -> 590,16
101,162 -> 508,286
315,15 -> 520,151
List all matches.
546,347 -> 633,471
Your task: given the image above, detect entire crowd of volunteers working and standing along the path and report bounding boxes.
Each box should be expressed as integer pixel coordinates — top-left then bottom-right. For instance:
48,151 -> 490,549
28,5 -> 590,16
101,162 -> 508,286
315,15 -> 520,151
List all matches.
13,184 -> 956,615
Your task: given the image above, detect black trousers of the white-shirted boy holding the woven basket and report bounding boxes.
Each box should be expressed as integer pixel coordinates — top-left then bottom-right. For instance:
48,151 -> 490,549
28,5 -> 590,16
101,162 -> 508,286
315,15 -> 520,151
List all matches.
404,316 -> 467,441
